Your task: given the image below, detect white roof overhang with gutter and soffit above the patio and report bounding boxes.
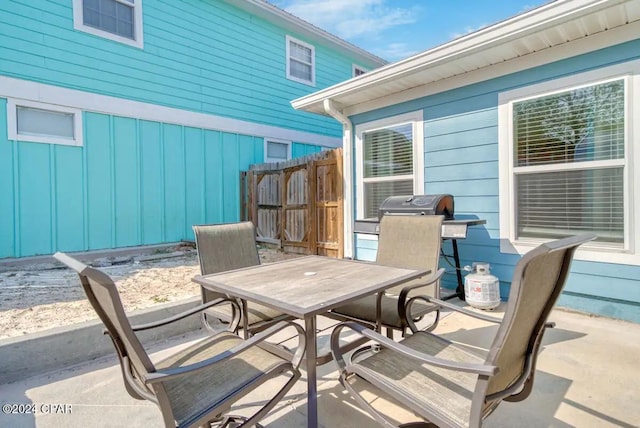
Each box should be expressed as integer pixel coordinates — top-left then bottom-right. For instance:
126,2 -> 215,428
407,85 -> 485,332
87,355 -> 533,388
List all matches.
291,0 -> 640,116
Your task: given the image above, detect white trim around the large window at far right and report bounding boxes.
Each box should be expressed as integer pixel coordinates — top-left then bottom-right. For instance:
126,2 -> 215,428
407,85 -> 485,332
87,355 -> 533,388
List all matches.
498,60 -> 640,265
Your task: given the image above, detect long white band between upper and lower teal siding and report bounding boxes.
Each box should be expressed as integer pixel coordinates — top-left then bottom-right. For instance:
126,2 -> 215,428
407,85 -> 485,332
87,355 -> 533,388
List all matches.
0,76 -> 342,147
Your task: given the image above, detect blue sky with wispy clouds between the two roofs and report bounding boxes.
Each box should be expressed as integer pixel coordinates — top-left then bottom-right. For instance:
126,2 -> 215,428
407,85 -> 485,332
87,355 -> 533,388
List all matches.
269,0 -> 549,62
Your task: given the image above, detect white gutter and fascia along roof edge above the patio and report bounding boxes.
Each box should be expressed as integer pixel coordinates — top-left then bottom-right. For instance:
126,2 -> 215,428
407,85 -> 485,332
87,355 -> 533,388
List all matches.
291,0 -> 623,110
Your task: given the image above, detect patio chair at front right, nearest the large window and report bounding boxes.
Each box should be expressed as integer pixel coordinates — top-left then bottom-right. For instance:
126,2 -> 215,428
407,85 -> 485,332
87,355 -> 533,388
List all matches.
331,234 -> 595,427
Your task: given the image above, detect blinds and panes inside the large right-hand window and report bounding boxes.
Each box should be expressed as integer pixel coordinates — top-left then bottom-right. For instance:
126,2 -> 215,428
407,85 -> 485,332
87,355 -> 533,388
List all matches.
513,80 -> 625,242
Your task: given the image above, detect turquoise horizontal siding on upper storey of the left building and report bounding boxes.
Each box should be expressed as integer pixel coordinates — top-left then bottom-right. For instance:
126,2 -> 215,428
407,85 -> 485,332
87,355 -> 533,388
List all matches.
0,0 -> 373,136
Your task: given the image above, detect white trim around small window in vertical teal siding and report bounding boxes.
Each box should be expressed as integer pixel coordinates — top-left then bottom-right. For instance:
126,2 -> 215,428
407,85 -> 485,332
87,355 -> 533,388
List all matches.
7,98 -> 83,146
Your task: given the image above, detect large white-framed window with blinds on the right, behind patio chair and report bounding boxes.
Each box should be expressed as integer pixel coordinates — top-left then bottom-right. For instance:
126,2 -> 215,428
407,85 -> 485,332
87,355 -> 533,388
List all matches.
500,60 -> 638,261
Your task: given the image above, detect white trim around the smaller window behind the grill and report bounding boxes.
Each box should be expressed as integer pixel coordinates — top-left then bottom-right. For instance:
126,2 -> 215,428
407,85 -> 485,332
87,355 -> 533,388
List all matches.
355,110 -> 424,241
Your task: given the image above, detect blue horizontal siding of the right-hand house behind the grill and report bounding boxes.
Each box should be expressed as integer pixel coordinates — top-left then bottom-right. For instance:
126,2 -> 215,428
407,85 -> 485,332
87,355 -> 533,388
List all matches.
351,40 -> 640,322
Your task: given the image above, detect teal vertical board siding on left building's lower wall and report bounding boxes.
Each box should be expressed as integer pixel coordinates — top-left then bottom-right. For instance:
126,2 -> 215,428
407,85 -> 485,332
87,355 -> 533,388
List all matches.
0,105 -> 264,258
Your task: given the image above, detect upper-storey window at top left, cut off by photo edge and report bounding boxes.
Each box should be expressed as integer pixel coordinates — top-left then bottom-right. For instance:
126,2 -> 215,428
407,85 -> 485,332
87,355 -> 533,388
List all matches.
73,0 -> 143,48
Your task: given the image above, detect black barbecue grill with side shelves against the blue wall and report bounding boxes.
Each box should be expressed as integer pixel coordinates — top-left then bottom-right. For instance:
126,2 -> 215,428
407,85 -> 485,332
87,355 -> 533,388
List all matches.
353,194 -> 486,300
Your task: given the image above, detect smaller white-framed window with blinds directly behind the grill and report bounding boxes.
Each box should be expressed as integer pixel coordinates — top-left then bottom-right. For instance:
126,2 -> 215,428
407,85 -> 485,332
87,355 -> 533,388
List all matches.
356,112 -> 424,219
